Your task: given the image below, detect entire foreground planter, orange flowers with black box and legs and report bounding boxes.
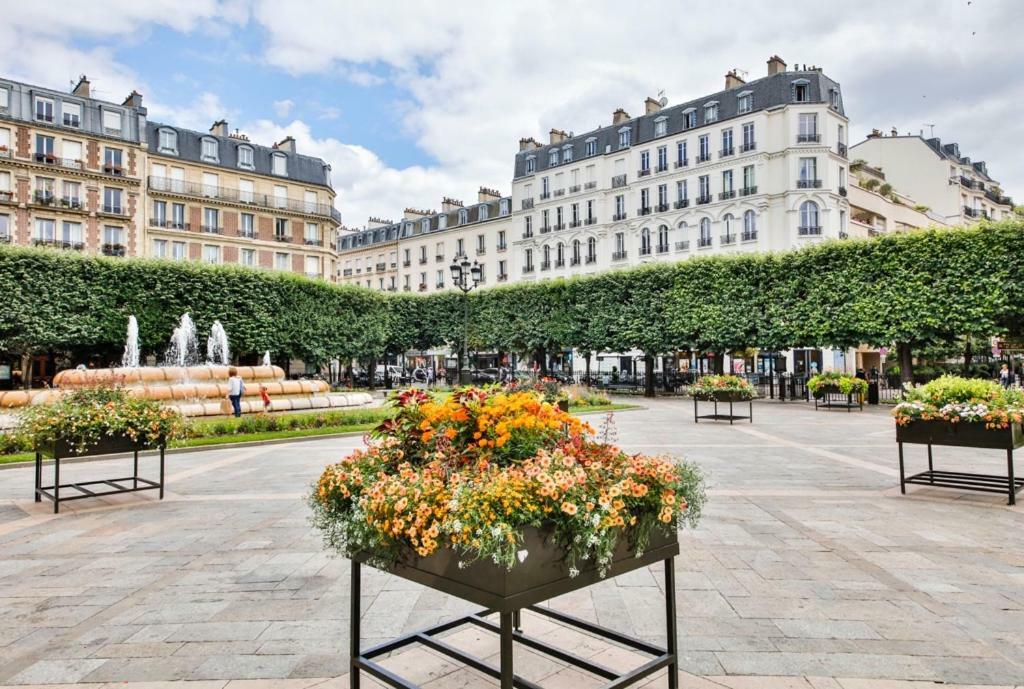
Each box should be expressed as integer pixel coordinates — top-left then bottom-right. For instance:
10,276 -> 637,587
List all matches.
310,388 -> 703,687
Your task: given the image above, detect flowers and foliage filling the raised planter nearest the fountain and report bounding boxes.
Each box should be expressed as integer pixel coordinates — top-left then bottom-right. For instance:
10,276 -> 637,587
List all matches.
17,387 -> 185,453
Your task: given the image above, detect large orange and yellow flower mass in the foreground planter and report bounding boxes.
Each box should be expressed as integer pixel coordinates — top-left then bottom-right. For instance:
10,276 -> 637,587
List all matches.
310,388 -> 705,574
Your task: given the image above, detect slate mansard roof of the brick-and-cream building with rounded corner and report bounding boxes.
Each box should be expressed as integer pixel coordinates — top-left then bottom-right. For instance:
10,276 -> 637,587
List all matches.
146,122 -> 331,187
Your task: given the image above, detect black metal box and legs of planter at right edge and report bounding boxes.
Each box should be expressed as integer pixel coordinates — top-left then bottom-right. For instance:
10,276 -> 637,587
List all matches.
896,421 -> 1024,505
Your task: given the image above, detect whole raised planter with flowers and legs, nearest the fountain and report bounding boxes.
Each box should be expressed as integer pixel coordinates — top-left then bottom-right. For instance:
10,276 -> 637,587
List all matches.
17,388 -> 184,514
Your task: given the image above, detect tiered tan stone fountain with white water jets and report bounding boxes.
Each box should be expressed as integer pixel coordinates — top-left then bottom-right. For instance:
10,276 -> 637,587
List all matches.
0,313 -> 373,417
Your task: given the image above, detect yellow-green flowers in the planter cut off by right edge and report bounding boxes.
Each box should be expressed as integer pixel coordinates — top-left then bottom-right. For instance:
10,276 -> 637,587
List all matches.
893,376 -> 1024,429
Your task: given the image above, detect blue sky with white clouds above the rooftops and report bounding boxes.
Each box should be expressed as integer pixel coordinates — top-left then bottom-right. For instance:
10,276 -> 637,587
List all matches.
0,0 -> 1024,227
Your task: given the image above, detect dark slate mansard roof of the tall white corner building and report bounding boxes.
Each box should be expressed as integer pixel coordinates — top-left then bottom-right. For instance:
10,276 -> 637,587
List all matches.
514,70 -> 845,178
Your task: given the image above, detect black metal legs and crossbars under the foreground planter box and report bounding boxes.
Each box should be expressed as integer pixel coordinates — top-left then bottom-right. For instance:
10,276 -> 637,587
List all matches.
348,557 -> 679,689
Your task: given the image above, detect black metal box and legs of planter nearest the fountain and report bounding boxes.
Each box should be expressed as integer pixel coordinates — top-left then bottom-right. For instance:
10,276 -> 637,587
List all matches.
35,435 -> 166,514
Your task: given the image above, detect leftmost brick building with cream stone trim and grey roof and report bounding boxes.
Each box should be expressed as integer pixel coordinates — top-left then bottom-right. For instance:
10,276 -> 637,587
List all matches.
0,77 -> 146,256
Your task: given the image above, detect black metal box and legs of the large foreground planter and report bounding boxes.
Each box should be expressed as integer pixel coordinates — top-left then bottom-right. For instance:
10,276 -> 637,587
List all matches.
349,527 -> 679,689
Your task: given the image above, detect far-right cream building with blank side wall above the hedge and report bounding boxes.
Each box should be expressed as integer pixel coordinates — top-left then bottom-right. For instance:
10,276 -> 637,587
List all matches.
851,129 -> 1014,225
